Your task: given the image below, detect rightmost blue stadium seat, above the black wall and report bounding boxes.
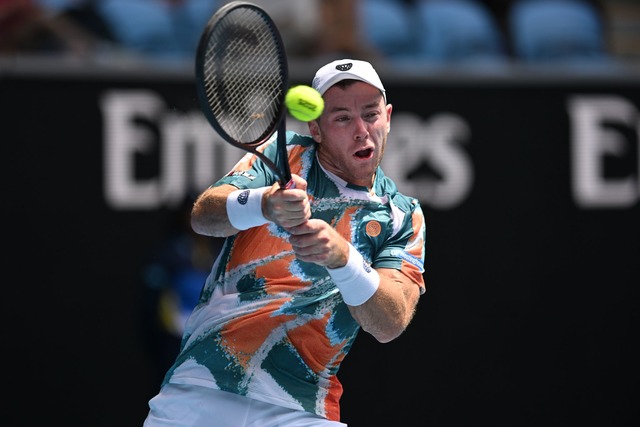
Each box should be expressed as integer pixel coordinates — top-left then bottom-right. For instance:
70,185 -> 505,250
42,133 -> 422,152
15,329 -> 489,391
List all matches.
508,0 -> 609,63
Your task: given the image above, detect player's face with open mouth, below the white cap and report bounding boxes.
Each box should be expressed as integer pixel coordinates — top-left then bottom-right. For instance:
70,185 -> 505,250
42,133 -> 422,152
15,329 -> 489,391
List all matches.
309,82 -> 392,187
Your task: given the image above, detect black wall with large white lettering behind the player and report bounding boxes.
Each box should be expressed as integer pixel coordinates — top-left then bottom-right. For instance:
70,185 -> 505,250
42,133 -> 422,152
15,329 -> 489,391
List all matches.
0,61 -> 640,427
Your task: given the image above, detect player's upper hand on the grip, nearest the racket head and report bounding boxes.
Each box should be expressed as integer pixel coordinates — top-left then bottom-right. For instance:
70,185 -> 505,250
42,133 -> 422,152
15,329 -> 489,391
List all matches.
262,175 -> 311,229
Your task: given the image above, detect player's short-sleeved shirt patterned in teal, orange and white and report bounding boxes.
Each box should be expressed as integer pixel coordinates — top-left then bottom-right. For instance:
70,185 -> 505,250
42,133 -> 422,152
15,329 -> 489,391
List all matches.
165,132 -> 426,421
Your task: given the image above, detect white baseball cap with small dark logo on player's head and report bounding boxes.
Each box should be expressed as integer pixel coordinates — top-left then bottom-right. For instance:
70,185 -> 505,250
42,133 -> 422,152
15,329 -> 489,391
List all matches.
311,59 -> 387,104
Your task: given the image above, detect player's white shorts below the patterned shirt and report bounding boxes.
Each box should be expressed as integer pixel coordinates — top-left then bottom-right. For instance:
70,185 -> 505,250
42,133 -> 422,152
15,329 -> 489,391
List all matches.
144,384 -> 346,427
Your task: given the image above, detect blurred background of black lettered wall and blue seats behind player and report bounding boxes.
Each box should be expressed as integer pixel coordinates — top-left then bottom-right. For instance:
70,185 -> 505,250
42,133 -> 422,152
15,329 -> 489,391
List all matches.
0,0 -> 640,427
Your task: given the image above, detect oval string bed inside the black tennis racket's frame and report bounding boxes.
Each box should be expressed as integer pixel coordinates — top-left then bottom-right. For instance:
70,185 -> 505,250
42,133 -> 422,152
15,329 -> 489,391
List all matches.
204,9 -> 286,144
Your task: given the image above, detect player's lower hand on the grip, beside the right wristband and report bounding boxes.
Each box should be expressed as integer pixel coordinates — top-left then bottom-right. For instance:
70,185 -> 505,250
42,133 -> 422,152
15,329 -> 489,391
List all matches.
287,219 -> 349,268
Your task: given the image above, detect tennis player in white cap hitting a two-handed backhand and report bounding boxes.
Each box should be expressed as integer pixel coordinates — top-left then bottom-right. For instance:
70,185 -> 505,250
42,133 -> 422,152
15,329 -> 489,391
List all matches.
144,59 -> 426,427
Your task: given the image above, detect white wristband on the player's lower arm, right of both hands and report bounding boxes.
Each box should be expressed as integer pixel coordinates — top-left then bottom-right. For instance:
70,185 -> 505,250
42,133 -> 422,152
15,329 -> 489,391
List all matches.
327,243 -> 380,306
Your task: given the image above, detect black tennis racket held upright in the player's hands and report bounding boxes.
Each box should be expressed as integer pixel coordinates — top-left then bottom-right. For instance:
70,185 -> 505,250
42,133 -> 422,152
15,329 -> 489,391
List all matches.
196,1 -> 293,188
